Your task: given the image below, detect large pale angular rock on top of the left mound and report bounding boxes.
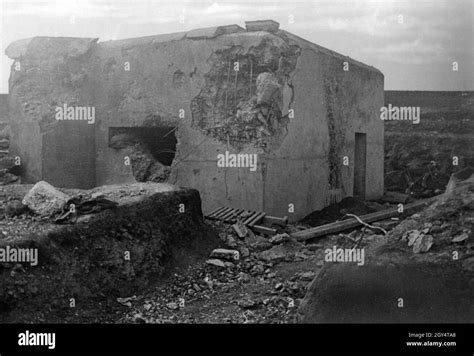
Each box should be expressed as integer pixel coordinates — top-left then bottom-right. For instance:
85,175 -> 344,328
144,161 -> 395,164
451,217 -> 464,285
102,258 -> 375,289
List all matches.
23,181 -> 70,216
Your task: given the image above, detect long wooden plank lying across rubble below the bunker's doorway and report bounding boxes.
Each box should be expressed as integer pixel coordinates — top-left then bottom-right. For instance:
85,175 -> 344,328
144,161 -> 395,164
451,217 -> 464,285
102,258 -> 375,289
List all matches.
291,197 -> 436,241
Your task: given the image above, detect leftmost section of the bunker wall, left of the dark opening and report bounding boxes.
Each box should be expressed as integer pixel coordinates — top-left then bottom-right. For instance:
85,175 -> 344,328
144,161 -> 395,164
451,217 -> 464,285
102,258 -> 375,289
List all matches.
6,37 -> 97,188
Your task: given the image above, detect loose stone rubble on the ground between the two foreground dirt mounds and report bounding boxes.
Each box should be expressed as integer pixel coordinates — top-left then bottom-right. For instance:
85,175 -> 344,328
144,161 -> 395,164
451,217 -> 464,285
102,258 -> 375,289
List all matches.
121,216 -> 394,323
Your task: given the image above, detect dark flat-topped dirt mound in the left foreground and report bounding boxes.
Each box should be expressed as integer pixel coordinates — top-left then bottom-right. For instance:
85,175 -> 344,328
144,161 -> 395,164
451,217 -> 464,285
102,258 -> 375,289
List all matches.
0,183 -> 218,322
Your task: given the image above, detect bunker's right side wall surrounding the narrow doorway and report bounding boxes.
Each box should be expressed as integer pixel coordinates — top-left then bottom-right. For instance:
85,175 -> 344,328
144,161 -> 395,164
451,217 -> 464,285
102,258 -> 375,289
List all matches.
265,32 -> 383,217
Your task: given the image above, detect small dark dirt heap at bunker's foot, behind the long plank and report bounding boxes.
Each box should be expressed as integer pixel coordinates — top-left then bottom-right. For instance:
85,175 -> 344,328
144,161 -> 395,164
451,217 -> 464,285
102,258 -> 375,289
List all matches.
300,197 -> 375,226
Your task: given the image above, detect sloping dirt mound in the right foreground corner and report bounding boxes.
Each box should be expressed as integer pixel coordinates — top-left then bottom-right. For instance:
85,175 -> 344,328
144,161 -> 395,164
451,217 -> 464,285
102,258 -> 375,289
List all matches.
299,176 -> 474,323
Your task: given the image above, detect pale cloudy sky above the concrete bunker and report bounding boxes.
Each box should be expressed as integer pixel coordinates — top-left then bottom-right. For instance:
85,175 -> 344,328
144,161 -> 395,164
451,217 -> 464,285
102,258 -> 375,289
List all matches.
0,0 -> 474,93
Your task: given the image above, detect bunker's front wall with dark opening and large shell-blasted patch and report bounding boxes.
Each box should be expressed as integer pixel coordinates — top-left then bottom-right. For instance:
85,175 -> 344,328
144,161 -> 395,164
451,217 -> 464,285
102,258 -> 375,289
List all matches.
92,29 -> 299,214
